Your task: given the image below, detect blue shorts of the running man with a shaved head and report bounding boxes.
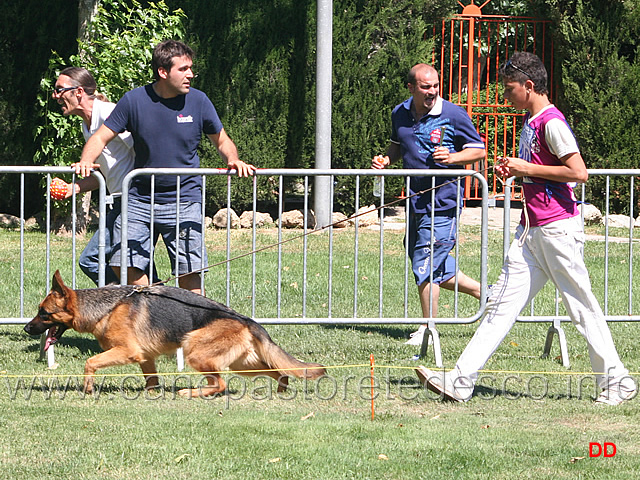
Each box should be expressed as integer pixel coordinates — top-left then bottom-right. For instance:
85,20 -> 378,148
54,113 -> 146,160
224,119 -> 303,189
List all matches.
405,214 -> 457,285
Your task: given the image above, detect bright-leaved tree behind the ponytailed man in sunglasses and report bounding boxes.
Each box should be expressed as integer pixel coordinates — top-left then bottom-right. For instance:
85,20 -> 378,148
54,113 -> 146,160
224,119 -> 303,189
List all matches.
34,0 -> 185,171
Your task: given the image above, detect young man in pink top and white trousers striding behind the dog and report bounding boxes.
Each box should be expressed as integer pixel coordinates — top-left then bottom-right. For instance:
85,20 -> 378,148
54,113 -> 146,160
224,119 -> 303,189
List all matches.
416,52 -> 636,405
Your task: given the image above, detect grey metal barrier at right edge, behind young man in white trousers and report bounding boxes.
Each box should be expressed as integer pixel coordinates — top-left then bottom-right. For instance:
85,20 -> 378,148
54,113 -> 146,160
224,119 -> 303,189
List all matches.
503,169 -> 640,368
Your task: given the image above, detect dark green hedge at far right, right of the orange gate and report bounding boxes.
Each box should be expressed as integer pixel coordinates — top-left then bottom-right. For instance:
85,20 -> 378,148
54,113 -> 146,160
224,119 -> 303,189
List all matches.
547,0 -> 640,214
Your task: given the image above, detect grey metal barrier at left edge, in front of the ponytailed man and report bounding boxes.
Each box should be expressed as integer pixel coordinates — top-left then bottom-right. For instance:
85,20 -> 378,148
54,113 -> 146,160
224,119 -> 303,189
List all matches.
0,166 -> 107,366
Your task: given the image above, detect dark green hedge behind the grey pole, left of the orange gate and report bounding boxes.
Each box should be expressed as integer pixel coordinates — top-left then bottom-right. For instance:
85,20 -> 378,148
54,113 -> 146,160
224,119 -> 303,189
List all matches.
169,0 -> 453,214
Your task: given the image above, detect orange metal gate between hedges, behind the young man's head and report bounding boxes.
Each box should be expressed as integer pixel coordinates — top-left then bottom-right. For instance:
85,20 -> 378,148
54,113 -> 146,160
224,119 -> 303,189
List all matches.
433,3 -> 555,200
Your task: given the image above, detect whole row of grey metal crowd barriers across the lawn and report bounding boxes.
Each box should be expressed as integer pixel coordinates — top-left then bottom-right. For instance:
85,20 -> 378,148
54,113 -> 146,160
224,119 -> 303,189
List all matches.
0,167 -> 640,367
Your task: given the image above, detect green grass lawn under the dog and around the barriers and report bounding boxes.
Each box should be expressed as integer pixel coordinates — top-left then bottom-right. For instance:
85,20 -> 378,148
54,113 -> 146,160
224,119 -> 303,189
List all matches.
0,229 -> 640,479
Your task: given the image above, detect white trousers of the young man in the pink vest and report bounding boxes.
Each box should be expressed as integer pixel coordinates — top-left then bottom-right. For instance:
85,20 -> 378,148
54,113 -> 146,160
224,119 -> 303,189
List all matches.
456,216 -> 629,388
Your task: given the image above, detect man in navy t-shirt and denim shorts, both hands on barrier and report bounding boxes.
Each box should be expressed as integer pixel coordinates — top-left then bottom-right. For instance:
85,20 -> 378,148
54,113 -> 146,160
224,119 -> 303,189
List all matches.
75,40 -> 255,293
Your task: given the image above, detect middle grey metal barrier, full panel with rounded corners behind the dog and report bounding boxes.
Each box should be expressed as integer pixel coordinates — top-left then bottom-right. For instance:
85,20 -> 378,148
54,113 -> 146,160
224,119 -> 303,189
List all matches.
121,169 -> 488,365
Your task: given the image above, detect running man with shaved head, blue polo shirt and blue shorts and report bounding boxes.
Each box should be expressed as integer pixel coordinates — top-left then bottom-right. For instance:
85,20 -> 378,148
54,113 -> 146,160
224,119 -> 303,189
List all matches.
372,63 -> 485,345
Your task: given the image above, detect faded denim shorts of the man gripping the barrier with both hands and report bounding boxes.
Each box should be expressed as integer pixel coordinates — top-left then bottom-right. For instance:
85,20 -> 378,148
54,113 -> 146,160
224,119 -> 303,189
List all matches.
111,198 -> 209,275
